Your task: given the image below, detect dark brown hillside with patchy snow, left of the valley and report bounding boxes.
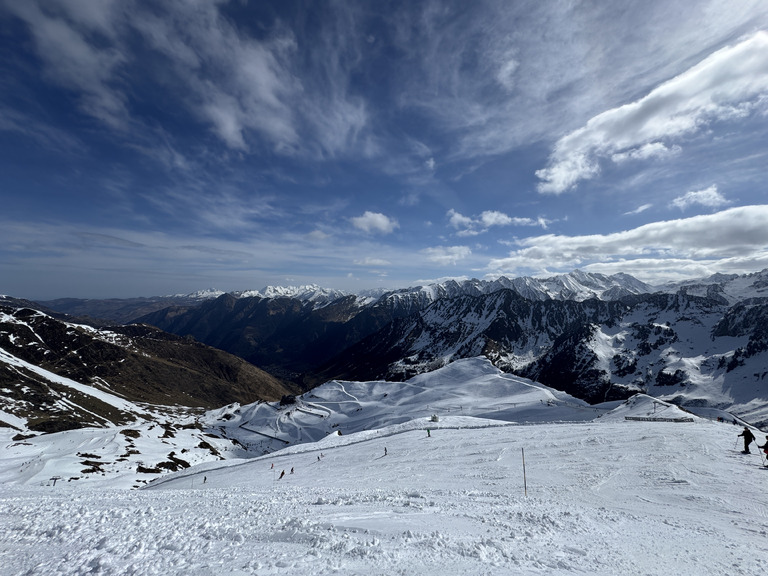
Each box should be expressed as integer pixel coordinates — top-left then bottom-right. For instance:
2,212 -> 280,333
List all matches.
0,306 -> 296,431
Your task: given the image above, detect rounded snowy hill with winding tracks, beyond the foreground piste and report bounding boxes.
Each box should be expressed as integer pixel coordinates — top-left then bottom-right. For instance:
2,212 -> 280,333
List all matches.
204,358 -> 605,454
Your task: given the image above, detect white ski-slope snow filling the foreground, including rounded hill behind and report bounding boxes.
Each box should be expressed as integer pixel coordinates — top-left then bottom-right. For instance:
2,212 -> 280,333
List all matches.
0,359 -> 768,576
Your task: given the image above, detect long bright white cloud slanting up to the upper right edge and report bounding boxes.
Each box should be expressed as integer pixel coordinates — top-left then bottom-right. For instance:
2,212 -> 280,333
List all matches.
536,31 -> 768,194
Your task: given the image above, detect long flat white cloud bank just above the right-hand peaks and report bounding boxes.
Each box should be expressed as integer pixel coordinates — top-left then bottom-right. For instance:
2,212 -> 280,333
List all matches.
488,205 -> 768,276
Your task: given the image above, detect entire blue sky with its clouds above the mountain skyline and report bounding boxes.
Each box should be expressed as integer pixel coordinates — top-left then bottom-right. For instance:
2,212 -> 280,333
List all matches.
0,0 -> 768,299
